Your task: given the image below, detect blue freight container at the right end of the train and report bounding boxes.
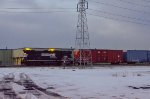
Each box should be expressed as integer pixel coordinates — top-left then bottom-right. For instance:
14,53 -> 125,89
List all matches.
127,50 -> 148,63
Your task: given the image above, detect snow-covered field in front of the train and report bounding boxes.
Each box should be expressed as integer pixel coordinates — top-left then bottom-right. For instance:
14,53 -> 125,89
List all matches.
0,66 -> 150,99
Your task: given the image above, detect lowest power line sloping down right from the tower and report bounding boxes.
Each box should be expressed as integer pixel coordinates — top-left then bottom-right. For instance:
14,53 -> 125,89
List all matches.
87,13 -> 150,26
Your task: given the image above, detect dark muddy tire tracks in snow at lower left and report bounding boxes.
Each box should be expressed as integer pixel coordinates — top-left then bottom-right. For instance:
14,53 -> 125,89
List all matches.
0,73 -> 69,99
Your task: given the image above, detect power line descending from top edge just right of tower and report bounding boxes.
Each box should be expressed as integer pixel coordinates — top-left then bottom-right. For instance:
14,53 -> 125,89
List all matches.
90,0 -> 150,14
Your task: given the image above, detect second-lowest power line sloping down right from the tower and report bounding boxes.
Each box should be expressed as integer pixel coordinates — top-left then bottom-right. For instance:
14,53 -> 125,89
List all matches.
89,9 -> 150,22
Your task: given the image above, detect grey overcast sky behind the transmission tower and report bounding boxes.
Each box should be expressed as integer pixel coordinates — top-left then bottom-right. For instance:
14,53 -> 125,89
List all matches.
0,0 -> 150,50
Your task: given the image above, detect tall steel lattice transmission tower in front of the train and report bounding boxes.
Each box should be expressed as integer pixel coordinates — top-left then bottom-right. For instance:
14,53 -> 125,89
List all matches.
75,0 -> 92,65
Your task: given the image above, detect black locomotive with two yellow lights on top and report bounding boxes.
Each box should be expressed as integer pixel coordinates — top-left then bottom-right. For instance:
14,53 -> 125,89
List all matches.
22,48 -> 73,66
